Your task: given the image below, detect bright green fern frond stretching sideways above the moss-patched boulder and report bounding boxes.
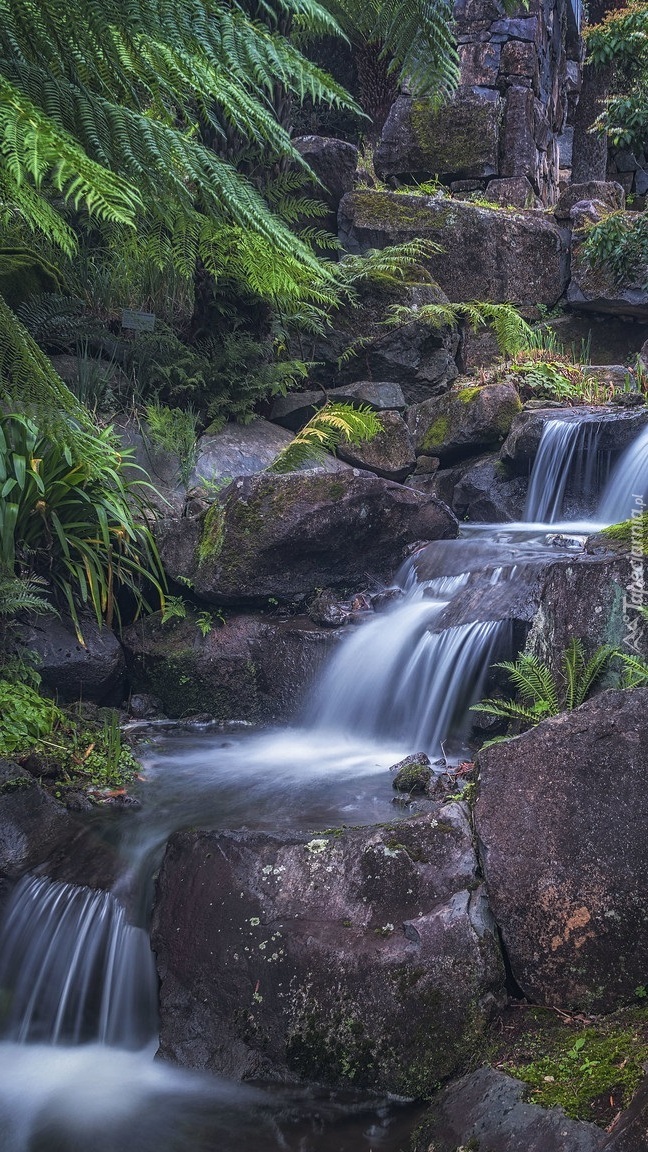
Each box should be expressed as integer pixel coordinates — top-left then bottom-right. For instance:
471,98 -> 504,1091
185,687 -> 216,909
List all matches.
387,301 -> 533,356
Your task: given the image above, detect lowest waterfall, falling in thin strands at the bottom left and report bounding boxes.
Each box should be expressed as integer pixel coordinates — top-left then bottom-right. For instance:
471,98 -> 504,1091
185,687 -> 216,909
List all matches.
0,877 -> 157,1049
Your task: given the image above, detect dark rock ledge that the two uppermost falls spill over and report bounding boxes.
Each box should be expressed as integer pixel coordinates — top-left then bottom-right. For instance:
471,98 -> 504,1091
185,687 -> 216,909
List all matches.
500,407 -> 648,472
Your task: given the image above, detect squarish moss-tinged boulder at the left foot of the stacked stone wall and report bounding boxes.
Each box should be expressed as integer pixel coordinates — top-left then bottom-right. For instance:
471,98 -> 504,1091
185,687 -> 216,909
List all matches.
374,91 -> 503,180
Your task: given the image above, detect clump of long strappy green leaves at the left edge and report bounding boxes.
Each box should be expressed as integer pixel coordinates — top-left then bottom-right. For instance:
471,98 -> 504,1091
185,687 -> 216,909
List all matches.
0,414 -> 164,635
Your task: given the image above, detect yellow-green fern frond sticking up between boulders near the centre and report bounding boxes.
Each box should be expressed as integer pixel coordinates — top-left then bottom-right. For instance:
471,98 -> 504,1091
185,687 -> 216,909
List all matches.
269,403 -> 383,472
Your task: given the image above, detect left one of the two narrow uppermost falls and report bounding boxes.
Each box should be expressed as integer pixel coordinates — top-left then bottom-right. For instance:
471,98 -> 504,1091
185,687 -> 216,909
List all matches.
523,419 -> 601,524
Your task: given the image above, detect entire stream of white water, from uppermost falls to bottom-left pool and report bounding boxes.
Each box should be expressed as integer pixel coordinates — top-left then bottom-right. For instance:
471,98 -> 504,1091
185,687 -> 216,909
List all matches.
0,407 -> 648,1152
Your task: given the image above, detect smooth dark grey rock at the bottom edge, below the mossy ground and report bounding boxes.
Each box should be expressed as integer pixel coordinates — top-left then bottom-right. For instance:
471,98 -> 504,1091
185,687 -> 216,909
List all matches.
415,1068 -> 608,1152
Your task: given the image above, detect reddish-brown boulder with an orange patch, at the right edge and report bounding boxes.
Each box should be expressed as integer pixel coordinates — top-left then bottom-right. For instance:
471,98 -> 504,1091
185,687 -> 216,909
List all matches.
475,689 -> 648,1011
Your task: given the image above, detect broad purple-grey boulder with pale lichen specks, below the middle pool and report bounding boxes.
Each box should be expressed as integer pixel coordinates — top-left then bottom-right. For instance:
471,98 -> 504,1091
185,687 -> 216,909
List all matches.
153,804 -> 503,1096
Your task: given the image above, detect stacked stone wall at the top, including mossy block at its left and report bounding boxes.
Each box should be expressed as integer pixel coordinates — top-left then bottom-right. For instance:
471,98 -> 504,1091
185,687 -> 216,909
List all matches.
376,0 -> 580,206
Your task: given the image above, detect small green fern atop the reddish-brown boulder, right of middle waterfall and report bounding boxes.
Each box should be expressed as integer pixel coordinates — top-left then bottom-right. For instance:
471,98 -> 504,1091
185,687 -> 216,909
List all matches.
472,637 -> 616,725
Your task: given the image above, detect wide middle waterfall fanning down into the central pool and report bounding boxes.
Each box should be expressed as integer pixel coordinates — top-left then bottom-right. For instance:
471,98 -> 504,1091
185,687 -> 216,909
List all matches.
308,571 -> 508,756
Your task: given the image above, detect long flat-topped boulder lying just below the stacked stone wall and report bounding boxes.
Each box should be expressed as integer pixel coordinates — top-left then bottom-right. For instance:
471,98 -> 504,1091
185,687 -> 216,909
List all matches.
339,189 -> 568,306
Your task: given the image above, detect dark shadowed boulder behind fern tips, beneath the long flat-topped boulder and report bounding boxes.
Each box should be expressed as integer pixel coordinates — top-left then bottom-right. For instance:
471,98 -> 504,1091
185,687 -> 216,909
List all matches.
304,282 -> 459,403
